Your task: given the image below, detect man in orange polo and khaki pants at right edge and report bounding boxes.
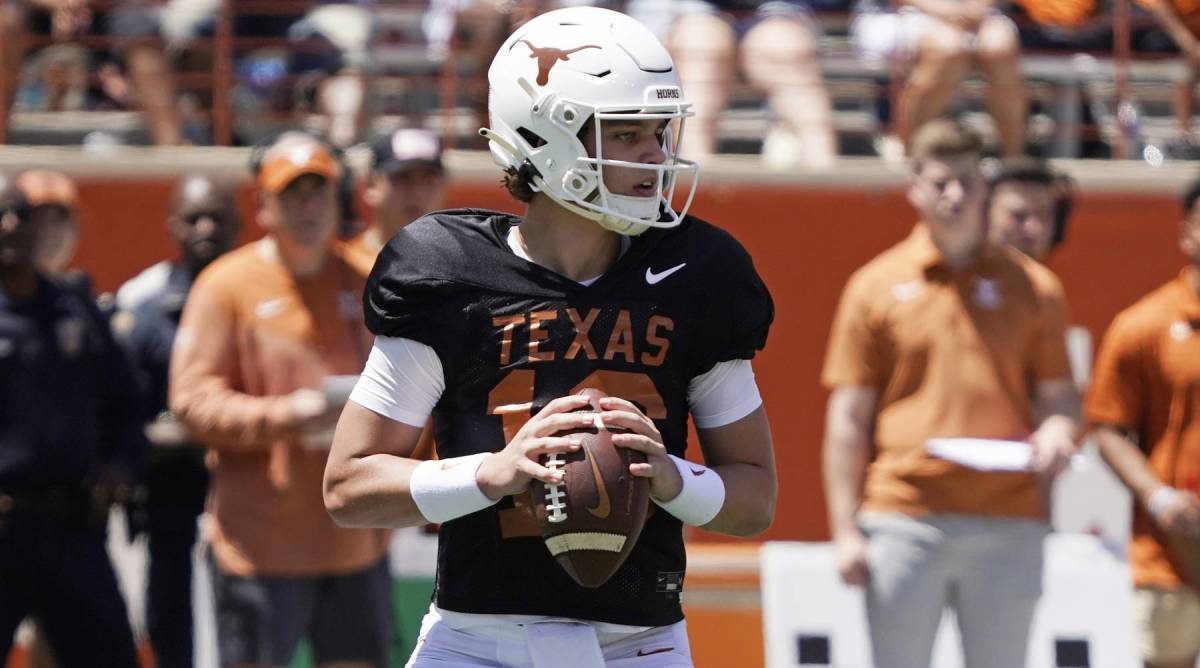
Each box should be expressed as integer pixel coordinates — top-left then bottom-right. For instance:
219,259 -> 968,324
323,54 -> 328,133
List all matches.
1086,181 -> 1200,668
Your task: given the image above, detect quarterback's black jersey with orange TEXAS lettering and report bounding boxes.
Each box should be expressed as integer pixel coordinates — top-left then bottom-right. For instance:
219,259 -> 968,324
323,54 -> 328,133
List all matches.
364,210 -> 773,626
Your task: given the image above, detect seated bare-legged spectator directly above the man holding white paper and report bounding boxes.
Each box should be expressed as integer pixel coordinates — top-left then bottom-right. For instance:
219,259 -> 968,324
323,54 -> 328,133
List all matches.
851,0 -> 1026,156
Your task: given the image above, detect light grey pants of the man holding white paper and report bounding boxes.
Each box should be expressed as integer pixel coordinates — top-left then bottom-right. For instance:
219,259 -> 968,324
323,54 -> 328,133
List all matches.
859,513 -> 1049,668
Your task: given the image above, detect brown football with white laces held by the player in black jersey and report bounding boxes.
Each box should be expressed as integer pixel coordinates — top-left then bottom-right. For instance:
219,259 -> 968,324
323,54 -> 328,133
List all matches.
529,390 -> 650,586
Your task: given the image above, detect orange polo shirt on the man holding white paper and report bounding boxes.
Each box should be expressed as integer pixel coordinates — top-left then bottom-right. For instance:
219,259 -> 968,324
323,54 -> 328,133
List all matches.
822,224 -> 1070,518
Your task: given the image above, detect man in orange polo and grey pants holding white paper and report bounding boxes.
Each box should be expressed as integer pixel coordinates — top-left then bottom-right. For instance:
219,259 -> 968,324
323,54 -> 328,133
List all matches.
822,120 -> 1079,668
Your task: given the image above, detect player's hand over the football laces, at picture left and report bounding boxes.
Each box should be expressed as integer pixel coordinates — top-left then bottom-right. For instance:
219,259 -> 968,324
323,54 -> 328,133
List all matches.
475,395 -> 595,499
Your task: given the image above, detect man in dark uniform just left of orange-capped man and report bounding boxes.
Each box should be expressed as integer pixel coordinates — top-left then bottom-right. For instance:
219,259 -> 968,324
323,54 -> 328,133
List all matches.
112,175 -> 239,668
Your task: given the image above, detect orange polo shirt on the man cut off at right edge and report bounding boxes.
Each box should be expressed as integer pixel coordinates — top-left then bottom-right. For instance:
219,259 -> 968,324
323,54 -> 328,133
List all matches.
1084,267 -> 1200,586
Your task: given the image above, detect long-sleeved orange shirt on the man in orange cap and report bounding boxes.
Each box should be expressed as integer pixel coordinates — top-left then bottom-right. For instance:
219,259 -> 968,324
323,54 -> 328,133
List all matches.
170,240 -> 386,576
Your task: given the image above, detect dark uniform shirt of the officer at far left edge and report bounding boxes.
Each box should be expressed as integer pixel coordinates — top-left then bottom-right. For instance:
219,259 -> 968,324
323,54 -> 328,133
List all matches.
0,273 -> 146,488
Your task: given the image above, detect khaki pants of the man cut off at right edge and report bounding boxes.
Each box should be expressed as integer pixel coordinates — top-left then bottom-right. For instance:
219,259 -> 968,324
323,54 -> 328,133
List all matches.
1133,586 -> 1200,663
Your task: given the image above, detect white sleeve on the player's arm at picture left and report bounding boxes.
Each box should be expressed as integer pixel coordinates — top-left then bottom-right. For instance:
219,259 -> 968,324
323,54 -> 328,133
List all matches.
350,336 -> 446,427
